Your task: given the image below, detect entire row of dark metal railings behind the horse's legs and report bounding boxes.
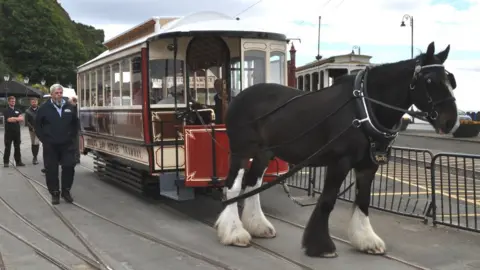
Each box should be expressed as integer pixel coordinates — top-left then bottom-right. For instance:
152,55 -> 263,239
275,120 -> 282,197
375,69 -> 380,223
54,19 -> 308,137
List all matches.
287,147 -> 480,232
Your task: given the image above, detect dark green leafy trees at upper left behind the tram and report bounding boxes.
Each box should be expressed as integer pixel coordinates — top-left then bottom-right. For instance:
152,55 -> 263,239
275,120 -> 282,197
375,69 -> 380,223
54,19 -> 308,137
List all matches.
0,0 -> 105,85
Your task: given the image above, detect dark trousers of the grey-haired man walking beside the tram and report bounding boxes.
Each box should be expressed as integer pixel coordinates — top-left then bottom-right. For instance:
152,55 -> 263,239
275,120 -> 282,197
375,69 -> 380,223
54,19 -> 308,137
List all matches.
43,143 -> 75,194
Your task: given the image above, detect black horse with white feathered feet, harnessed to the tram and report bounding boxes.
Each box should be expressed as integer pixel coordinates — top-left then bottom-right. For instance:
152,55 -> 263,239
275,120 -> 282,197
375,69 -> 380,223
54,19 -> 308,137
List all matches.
215,42 -> 459,257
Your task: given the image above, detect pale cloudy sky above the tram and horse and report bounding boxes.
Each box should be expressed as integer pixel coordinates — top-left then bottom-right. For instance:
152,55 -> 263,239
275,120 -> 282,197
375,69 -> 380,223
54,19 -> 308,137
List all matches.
58,0 -> 480,111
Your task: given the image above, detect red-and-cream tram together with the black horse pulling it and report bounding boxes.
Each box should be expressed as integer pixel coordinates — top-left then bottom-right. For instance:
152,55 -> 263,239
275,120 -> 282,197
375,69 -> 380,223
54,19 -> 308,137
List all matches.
77,12 -> 458,266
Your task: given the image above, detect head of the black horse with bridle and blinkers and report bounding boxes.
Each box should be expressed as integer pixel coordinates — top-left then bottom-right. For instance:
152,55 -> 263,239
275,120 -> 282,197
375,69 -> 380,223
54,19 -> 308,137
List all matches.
410,42 -> 460,134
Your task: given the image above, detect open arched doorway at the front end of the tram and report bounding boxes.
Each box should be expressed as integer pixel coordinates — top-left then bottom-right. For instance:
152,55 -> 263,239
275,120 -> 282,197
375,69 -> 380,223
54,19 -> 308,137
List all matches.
187,37 -> 230,124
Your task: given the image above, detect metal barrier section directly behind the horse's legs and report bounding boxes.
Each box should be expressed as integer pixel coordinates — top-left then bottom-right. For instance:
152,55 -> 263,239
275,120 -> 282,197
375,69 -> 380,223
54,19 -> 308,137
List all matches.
287,147 -> 433,219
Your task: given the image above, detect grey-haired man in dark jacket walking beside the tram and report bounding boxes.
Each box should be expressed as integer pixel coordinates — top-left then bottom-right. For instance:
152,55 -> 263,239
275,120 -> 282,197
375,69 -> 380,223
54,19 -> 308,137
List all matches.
35,84 -> 79,204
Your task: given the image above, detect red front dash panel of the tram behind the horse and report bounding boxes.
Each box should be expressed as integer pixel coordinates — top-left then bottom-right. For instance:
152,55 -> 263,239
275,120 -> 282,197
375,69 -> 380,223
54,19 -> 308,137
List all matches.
183,125 -> 288,187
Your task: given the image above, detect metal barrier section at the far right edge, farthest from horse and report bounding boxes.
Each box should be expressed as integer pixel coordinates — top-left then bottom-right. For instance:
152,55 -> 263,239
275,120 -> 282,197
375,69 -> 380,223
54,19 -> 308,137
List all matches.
431,153 -> 480,232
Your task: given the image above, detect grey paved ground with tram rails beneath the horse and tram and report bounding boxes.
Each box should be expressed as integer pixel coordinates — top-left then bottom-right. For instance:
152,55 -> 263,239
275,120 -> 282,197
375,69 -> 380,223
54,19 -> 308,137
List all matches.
0,127 -> 480,270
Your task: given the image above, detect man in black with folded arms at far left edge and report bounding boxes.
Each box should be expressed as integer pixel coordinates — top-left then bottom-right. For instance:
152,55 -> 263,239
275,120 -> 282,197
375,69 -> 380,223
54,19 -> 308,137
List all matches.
3,96 -> 25,168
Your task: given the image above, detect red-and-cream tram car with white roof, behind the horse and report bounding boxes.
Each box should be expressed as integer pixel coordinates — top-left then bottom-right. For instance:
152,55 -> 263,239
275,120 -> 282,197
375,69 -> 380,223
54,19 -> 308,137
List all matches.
77,12 -> 289,200
